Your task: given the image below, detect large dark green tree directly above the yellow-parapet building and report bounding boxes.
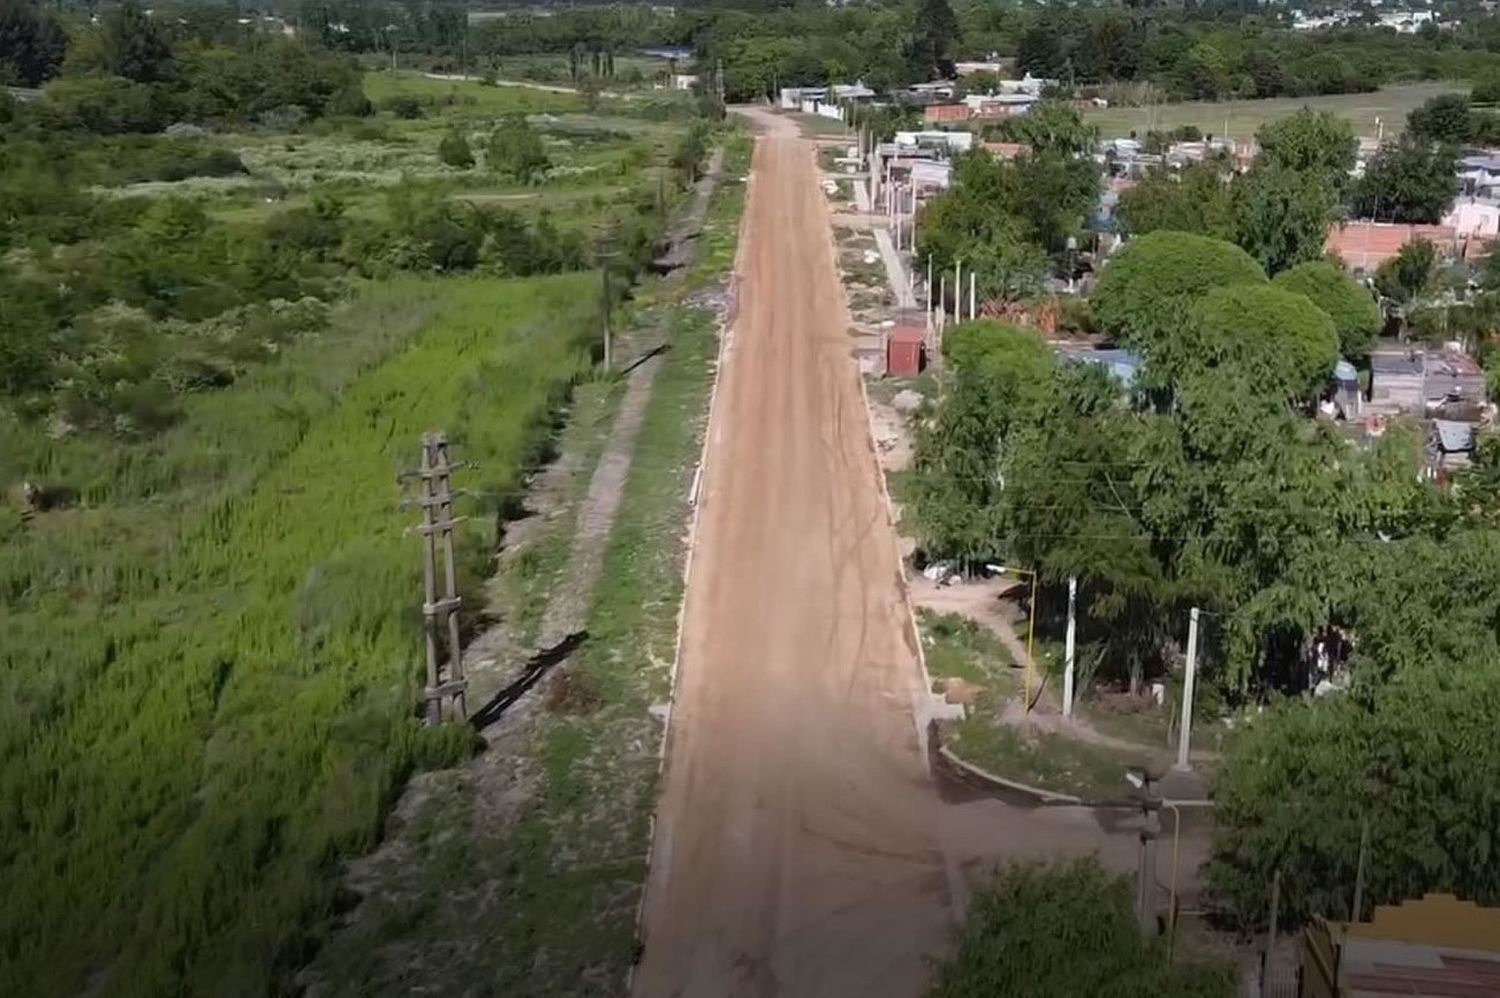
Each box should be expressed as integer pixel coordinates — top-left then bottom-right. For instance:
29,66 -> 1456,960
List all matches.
1206,660 -> 1500,929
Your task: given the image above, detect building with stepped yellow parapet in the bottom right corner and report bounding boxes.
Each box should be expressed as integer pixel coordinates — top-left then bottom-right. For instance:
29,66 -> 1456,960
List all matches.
1298,894 -> 1500,998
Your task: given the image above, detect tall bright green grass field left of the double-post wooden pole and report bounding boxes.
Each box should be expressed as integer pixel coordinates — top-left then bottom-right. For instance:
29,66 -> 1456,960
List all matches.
0,275 -> 593,996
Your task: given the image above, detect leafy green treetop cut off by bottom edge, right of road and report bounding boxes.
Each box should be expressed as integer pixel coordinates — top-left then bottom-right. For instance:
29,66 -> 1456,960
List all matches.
929,857 -> 1235,998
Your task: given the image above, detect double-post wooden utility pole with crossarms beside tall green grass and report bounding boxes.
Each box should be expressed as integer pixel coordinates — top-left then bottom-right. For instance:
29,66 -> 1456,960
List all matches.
401,432 -> 468,726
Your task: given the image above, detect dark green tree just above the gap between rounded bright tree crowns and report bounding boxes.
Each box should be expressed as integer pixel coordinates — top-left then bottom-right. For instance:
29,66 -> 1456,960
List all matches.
1233,164 -> 1338,273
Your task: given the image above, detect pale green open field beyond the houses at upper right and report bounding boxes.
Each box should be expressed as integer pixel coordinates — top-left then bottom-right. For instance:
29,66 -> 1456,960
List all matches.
1086,83 -> 1469,138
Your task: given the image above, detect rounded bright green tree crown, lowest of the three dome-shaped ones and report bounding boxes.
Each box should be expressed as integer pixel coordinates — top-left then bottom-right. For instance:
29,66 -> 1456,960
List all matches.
1188,284 -> 1338,401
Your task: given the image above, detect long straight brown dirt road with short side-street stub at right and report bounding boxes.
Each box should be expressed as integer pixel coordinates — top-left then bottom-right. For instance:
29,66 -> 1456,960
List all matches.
635,114 -> 1194,998
